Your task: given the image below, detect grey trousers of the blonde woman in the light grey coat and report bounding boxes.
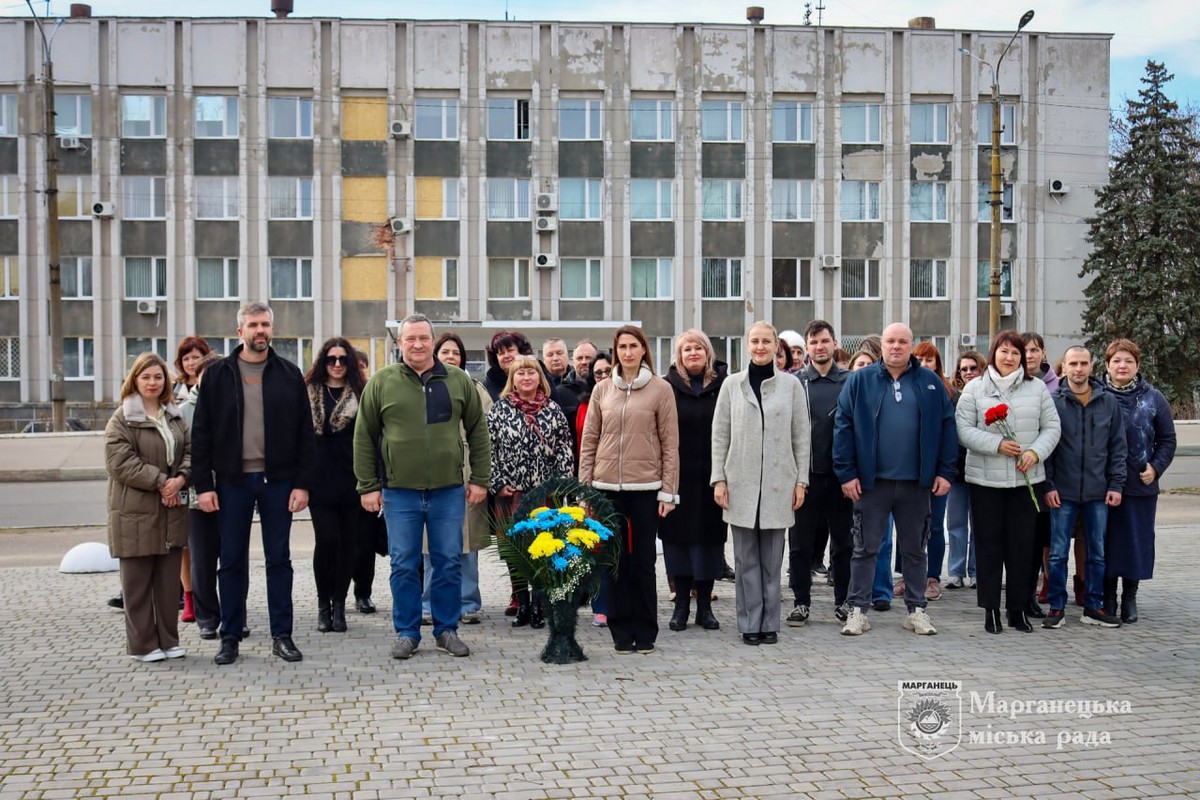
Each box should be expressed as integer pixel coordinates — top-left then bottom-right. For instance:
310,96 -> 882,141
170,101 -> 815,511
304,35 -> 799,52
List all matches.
730,525 -> 787,633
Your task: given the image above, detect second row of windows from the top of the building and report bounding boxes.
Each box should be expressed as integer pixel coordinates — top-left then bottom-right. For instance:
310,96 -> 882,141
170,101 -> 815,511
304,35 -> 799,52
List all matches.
0,175 -> 1013,222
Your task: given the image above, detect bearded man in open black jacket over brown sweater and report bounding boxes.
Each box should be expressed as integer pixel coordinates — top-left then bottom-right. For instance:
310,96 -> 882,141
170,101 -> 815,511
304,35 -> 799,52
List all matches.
192,302 -> 314,664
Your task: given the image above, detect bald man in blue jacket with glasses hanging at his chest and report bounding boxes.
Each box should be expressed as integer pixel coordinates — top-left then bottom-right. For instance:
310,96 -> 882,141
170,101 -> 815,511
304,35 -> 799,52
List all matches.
833,323 -> 958,636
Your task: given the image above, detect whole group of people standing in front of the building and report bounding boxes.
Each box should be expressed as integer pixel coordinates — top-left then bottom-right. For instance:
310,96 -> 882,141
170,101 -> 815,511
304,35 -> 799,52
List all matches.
107,303 -> 1175,664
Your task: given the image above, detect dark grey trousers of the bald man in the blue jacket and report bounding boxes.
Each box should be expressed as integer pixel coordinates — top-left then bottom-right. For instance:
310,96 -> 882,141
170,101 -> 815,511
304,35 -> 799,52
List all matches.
846,480 -> 934,612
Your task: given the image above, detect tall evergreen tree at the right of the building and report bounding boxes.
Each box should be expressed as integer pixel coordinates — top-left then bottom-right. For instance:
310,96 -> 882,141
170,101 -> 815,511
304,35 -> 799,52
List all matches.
1080,61 -> 1200,410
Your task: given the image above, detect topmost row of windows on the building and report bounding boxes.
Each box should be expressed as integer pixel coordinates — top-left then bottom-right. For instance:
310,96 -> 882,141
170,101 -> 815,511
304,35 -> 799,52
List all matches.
0,94 -> 1016,145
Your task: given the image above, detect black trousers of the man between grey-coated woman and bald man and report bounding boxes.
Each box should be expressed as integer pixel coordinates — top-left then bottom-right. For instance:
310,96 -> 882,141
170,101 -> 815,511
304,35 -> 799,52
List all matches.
787,475 -> 854,606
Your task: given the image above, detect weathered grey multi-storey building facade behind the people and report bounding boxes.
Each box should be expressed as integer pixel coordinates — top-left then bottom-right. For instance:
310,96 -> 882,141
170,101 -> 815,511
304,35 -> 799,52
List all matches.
0,18 -> 1110,403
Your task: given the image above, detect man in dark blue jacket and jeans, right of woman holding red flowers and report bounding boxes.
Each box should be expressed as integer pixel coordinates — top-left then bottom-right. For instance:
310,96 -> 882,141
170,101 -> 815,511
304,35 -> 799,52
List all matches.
1042,347 -> 1128,627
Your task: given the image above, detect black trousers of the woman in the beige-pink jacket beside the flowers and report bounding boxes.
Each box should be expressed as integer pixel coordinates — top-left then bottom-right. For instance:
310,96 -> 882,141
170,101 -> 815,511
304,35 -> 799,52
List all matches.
605,489 -> 659,648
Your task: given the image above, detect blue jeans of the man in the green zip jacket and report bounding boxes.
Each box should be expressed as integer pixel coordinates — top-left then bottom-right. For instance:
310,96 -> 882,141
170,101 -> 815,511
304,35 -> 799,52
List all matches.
383,486 -> 467,642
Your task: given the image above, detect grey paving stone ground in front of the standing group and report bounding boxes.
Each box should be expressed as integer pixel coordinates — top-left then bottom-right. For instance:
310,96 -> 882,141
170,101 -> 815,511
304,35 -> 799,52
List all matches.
0,503 -> 1200,800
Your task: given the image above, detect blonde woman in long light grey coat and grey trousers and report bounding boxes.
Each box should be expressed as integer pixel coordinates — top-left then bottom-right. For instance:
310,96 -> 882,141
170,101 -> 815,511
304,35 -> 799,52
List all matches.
712,321 -> 810,645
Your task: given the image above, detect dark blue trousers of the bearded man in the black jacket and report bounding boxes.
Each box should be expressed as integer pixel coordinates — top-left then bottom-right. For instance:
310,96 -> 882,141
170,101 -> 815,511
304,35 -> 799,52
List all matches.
217,473 -> 292,639
